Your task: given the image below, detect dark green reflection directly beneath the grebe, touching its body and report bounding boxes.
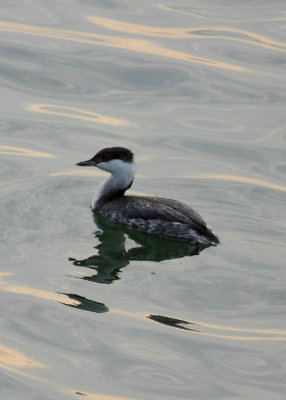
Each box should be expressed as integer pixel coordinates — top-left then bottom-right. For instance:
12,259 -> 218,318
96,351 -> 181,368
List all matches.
69,214 -> 208,284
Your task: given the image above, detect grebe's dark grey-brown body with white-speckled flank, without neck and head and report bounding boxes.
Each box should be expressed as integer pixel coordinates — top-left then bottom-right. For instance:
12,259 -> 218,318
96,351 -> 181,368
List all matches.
94,196 -> 219,244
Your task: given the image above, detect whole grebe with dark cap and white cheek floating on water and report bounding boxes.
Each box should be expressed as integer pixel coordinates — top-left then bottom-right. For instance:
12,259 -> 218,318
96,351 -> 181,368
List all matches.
76,147 -> 219,246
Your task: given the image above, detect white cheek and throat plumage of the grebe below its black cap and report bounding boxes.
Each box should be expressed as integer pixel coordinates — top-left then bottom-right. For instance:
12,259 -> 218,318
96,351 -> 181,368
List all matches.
91,160 -> 135,210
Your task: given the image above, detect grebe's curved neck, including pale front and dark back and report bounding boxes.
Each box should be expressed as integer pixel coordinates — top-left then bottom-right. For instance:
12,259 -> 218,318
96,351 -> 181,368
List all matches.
91,163 -> 135,210
